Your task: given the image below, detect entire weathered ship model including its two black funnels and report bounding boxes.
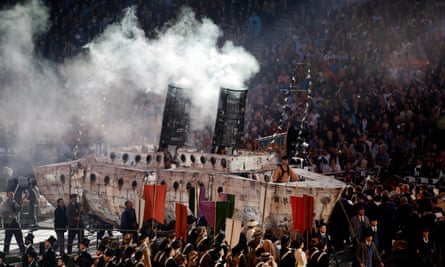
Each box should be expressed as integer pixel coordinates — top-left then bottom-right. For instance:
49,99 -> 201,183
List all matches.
34,86 -> 345,232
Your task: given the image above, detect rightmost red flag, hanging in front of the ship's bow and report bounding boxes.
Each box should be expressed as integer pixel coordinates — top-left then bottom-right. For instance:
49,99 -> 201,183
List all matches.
290,195 -> 314,233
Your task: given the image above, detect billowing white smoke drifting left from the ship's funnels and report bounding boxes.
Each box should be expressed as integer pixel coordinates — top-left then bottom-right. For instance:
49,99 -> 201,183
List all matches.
0,1 -> 259,168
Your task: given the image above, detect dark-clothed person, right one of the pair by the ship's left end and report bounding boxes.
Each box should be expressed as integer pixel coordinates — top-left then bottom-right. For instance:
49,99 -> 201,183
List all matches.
66,194 -> 83,254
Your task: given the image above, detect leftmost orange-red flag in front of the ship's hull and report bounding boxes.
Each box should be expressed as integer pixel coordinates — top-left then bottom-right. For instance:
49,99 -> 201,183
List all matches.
144,184 -> 167,223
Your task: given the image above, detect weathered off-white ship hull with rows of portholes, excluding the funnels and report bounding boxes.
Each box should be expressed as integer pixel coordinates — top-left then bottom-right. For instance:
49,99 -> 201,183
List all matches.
34,152 -> 346,230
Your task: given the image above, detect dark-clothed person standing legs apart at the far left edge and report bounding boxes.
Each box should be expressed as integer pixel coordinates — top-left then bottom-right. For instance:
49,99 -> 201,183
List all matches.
1,191 -> 25,255
